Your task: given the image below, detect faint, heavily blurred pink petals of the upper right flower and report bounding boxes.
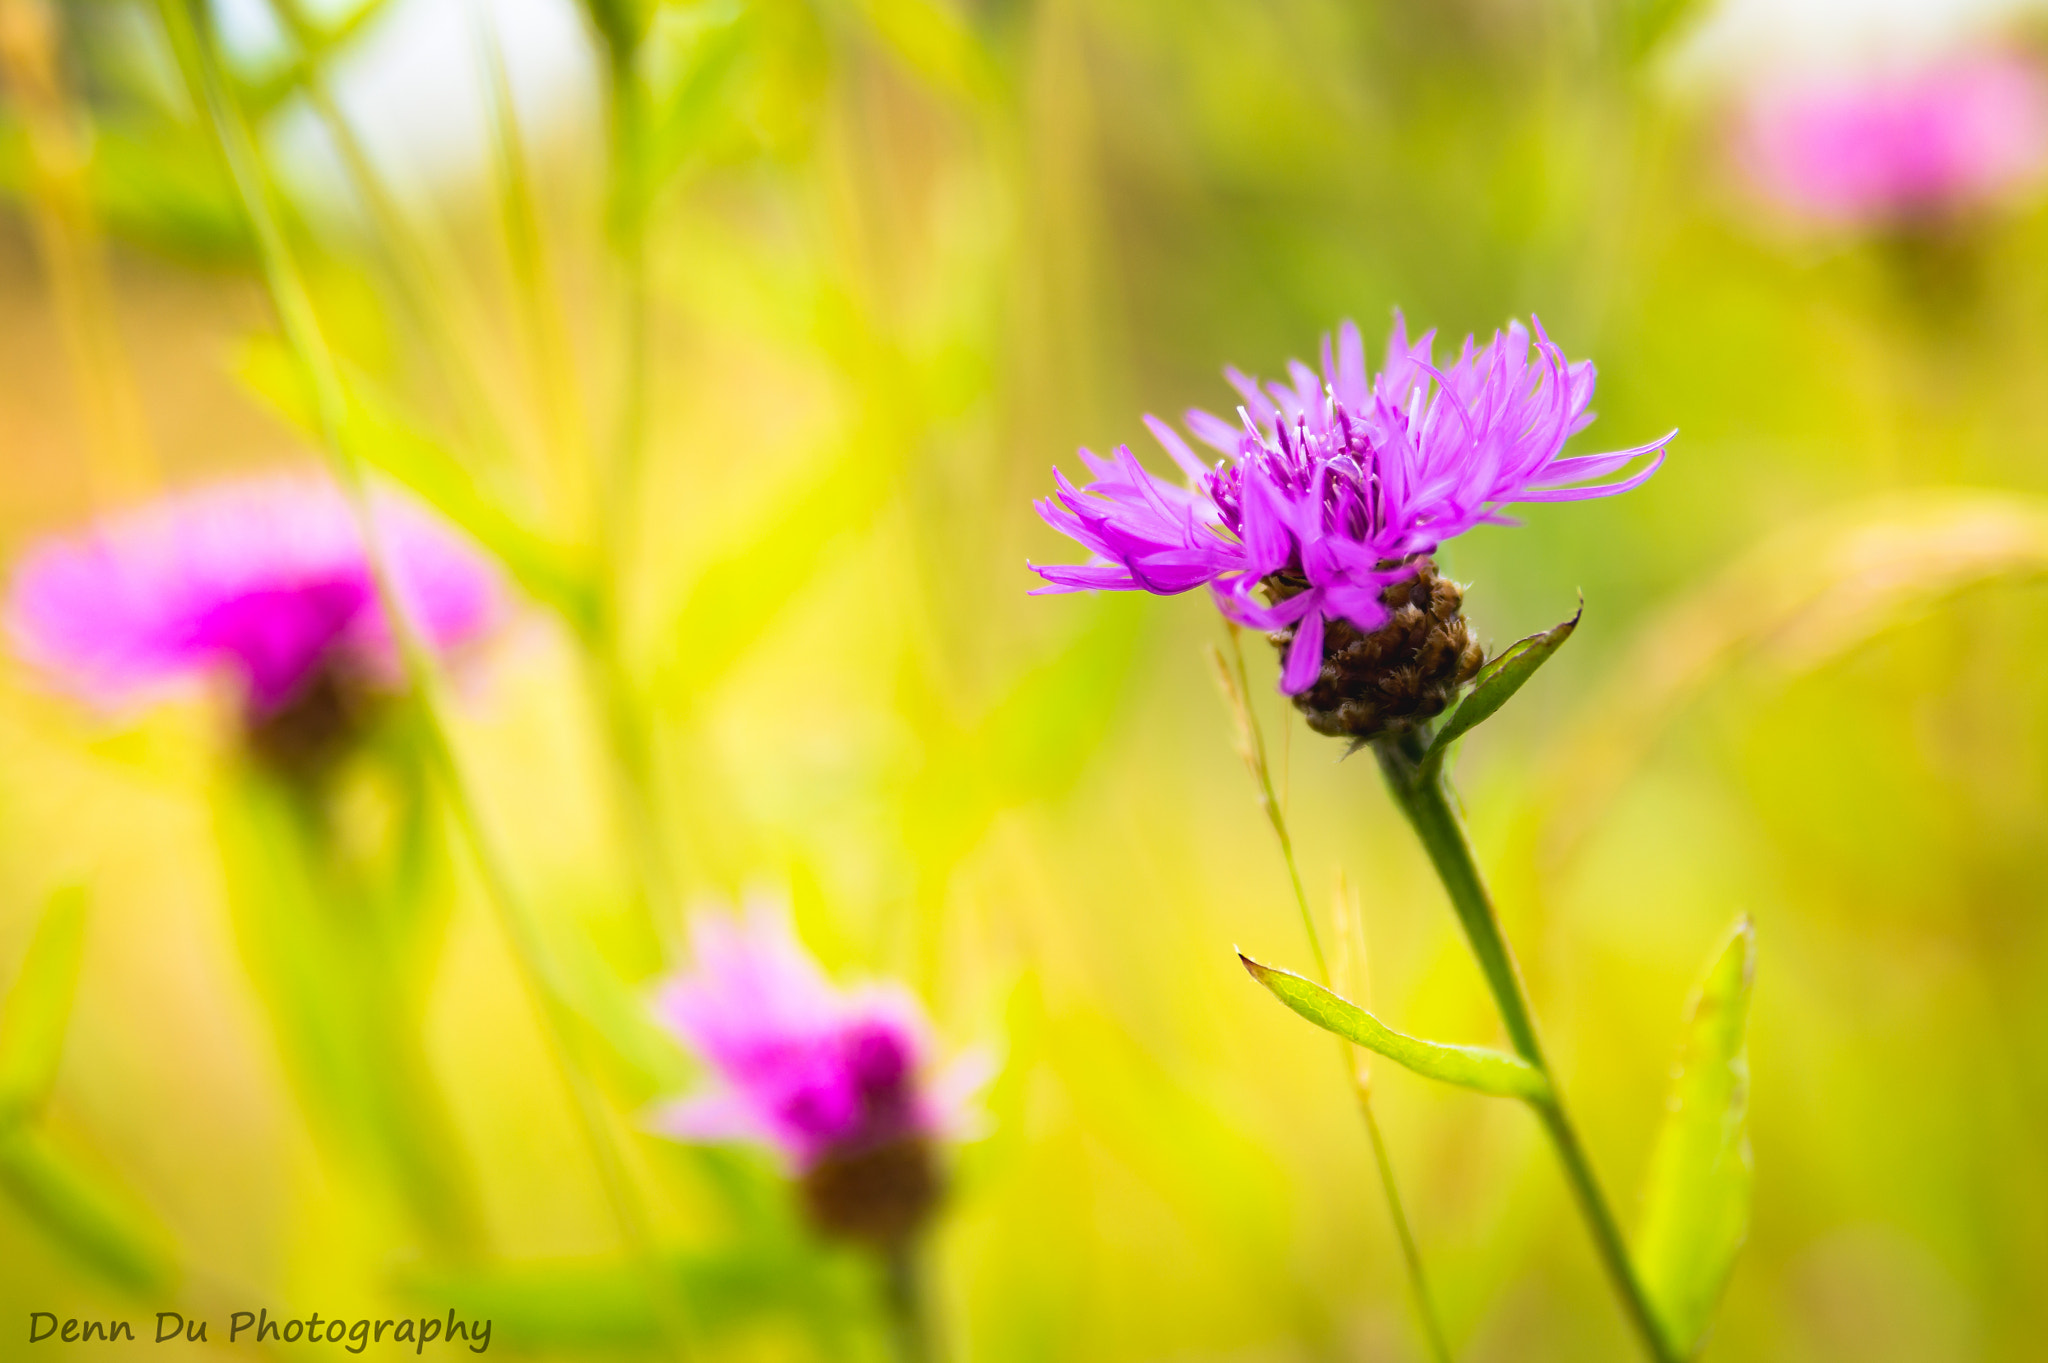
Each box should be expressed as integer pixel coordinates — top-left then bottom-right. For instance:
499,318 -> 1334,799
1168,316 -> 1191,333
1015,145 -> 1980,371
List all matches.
1737,53 -> 2048,225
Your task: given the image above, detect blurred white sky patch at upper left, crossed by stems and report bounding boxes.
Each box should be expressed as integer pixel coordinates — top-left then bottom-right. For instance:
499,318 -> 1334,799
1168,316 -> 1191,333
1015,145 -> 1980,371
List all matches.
226,0 -> 600,215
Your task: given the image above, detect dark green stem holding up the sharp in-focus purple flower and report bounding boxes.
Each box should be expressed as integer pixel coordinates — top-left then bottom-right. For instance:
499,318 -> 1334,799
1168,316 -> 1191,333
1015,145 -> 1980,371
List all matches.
1372,731 -> 1683,1363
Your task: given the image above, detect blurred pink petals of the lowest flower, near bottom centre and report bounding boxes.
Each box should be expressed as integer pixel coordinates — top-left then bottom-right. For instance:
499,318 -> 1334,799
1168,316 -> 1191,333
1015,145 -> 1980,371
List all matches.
653,903 -> 985,1171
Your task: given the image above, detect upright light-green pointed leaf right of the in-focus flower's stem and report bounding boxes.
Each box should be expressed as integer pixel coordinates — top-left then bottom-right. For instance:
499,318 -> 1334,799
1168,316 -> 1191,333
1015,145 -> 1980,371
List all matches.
1636,919 -> 1757,1357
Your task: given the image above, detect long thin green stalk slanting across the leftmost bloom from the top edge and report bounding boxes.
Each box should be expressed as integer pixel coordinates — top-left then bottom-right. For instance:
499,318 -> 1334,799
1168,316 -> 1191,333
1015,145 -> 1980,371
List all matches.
158,0 -> 686,1355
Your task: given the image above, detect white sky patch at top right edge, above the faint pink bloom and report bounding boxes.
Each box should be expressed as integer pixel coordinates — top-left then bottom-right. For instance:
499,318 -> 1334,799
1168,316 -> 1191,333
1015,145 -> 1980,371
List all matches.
1665,0 -> 2048,90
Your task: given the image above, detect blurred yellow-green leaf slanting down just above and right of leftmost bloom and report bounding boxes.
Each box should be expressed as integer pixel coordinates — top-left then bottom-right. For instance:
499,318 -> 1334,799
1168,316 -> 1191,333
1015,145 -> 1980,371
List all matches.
233,336 -> 594,628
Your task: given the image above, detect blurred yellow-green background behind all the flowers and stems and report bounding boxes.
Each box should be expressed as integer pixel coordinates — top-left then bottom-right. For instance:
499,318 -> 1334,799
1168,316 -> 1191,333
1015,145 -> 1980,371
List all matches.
0,0 -> 2048,1363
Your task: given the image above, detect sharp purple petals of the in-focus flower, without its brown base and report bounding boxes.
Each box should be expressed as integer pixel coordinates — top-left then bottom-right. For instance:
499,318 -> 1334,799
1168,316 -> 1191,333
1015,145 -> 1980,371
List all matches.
1032,313 -> 1677,694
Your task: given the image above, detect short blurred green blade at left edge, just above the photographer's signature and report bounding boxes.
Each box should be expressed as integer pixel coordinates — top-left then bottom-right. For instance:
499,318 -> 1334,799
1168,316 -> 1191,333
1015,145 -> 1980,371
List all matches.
0,1126 -> 172,1298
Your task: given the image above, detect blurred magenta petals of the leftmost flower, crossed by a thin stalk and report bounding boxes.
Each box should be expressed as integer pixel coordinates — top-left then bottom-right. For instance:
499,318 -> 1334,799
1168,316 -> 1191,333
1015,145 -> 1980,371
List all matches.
6,473 -> 504,716
